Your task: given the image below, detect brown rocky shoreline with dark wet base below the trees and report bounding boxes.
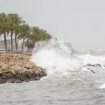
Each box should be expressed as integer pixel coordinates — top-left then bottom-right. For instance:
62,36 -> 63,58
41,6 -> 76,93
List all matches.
0,54 -> 46,83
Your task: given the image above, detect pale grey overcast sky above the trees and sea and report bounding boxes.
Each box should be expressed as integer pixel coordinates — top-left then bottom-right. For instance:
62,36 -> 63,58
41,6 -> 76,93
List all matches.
0,0 -> 105,50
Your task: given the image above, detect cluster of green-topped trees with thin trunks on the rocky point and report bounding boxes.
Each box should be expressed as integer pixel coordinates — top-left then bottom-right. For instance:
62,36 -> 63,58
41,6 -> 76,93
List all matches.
0,13 -> 51,52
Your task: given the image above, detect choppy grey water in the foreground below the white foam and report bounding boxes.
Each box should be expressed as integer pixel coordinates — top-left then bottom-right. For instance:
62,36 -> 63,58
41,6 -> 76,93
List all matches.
0,71 -> 105,105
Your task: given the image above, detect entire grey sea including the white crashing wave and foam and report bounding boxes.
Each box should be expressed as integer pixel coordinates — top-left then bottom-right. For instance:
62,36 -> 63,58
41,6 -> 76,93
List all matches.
0,40 -> 105,105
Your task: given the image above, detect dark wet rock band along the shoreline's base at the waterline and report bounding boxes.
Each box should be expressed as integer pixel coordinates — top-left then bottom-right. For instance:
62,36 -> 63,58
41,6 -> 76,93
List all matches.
0,71 -> 46,83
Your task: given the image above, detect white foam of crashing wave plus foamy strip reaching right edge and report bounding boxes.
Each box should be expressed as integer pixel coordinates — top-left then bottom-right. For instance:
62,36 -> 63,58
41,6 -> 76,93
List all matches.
31,39 -> 105,75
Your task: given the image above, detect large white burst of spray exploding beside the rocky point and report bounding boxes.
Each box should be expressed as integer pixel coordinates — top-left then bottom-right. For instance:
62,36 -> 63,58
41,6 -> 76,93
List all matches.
32,39 -> 80,75
